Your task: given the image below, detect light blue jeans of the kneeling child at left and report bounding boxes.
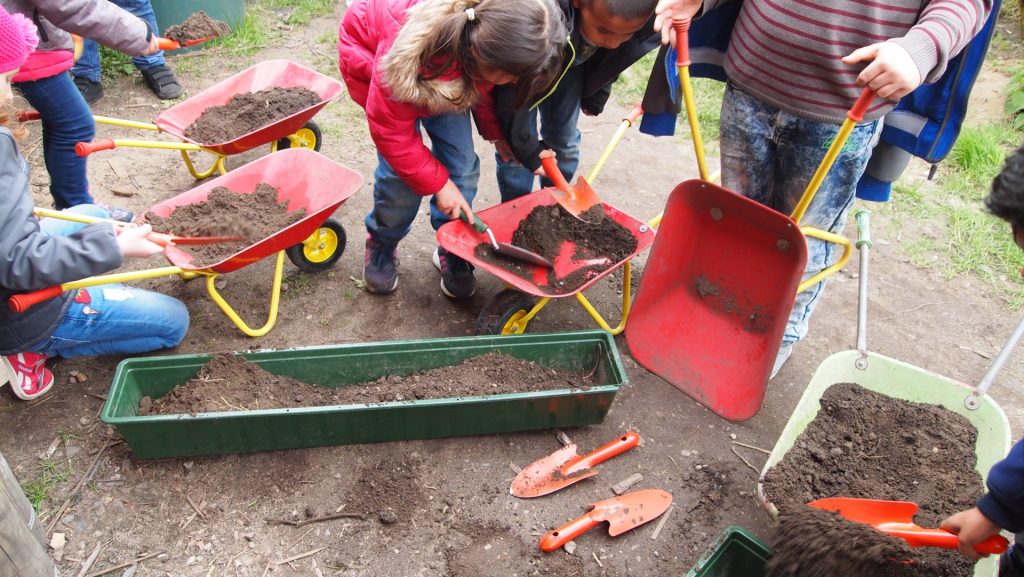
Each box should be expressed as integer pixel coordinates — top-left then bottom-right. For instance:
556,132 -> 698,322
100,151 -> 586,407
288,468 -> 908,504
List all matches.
34,205 -> 188,359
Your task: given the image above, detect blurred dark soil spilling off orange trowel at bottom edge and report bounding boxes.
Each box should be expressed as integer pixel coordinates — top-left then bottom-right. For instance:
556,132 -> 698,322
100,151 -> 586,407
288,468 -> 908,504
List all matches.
765,505 -> 916,577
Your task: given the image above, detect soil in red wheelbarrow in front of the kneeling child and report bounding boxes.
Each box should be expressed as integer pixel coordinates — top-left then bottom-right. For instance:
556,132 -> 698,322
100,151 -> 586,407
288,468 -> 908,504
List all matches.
145,182 -> 306,267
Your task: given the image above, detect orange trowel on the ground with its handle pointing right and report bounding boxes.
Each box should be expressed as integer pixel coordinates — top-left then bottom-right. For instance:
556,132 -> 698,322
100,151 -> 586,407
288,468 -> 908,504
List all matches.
509,430 -> 640,499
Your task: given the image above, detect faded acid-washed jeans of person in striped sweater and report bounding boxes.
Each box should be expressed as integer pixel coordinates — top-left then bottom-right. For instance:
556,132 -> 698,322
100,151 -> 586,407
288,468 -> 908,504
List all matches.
721,85 -> 882,343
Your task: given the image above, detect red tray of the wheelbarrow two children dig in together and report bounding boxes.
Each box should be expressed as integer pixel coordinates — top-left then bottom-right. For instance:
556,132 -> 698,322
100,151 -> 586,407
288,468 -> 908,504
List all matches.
437,189 -> 654,298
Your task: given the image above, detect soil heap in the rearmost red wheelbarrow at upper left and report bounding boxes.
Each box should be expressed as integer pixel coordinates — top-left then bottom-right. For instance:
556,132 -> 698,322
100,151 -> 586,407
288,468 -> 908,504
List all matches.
185,86 -> 321,145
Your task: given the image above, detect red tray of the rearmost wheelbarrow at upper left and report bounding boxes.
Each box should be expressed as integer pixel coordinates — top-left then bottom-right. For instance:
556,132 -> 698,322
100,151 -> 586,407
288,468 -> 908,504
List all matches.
154,60 -> 342,156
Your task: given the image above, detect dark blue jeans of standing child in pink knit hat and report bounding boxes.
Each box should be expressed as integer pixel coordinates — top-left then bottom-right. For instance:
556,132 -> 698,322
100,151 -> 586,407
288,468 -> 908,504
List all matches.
14,73 -> 96,208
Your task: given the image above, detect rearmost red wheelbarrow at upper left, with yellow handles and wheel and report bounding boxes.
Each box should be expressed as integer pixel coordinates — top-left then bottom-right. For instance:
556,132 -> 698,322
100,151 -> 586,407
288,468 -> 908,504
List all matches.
67,60 -> 342,179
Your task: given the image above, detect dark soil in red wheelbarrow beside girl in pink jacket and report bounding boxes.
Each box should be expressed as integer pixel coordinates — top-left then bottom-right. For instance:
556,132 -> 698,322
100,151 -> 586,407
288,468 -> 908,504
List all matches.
475,204 -> 637,294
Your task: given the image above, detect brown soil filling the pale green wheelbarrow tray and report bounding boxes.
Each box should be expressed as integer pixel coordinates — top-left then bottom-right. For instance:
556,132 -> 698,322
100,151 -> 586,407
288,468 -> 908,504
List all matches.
763,383 -> 984,577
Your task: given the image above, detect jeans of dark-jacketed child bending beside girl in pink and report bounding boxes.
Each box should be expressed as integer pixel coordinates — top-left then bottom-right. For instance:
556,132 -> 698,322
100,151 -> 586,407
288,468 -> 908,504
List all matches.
495,82 -> 583,202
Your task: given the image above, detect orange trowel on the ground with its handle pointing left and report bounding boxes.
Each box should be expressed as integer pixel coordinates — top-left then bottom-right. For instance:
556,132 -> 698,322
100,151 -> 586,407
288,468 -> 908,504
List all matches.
541,489 -> 672,552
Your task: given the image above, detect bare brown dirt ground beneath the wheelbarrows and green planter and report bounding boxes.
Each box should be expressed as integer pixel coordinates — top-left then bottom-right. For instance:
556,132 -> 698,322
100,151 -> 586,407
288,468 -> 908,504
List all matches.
0,4 -> 1024,577
